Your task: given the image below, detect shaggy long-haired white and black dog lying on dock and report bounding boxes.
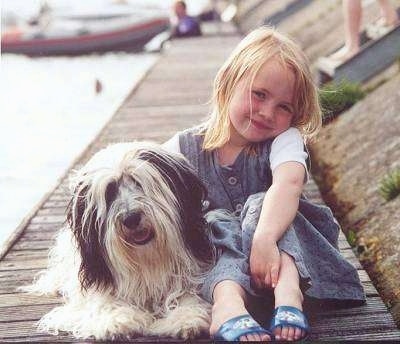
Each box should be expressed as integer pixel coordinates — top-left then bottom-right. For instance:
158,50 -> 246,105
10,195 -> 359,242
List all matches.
24,142 -> 213,339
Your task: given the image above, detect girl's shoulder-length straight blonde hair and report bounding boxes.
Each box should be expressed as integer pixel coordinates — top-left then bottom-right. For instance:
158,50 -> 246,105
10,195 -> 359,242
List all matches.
202,26 -> 322,150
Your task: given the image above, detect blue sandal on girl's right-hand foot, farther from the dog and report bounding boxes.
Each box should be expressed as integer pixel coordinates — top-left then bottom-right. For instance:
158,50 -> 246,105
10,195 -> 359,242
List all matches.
269,306 -> 310,340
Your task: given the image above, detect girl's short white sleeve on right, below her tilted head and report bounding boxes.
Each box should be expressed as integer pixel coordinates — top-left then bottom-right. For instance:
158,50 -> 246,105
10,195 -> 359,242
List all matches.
269,128 -> 308,180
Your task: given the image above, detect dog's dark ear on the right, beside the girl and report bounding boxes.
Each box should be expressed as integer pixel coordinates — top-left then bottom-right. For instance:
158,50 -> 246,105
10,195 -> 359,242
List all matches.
140,150 -> 212,261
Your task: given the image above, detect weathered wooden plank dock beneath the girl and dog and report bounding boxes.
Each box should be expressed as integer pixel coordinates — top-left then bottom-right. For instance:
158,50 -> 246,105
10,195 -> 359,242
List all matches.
0,22 -> 400,342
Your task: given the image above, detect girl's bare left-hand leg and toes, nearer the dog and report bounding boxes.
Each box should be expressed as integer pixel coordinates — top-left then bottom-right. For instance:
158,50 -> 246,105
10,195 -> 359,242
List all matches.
210,280 -> 271,341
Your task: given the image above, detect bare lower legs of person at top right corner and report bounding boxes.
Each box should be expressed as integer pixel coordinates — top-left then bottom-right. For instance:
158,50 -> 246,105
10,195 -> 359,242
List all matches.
329,0 -> 399,62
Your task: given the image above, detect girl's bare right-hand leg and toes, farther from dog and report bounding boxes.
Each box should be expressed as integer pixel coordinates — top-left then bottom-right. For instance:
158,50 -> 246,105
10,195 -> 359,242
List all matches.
274,252 -> 304,340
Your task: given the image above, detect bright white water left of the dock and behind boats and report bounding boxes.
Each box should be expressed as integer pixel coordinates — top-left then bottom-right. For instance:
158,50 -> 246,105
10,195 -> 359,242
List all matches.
0,0 -> 208,245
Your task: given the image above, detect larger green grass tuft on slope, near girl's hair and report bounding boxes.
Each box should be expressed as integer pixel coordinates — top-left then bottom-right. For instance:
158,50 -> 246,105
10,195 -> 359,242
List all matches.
319,80 -> 366,121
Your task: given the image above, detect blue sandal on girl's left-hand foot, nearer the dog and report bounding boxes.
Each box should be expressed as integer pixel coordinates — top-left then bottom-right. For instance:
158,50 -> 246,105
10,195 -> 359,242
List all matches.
213,314 -> 273,342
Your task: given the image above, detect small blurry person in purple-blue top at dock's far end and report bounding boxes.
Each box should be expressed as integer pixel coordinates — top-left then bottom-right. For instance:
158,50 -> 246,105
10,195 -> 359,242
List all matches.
171,1 -> 201,37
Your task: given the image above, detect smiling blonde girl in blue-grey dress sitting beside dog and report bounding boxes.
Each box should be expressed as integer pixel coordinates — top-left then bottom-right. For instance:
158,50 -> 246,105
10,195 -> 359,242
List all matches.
165,27 -> 364,340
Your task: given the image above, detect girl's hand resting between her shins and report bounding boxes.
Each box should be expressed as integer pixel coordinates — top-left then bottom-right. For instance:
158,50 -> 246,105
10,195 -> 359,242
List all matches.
250,232 -> 281,289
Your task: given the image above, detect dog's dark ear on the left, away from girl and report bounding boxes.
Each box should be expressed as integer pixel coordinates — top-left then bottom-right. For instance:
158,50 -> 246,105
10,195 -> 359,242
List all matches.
67,184 -> 115,290
